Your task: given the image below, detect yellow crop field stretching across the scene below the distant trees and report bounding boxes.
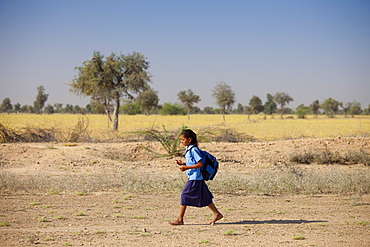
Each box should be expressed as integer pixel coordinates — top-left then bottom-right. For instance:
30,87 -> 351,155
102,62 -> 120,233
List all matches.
0,114 -> 370,141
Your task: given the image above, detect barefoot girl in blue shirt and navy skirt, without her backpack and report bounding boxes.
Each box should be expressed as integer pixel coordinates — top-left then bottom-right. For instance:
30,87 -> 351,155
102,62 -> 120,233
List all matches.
169,129 -> 223,225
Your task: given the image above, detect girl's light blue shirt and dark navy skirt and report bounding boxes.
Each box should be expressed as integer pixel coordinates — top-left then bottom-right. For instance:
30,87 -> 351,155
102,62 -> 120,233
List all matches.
180,145 -> 213,207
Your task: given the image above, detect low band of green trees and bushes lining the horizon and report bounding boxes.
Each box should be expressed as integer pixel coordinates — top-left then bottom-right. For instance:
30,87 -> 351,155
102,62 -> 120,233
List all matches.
0,96 -> 370,118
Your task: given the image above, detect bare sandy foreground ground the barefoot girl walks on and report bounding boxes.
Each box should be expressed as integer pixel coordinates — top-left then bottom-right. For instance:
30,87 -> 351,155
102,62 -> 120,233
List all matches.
0,192 -> 370,246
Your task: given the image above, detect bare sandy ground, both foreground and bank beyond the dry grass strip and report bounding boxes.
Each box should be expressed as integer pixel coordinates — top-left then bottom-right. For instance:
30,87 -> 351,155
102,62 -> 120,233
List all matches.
0,137 -> 370,246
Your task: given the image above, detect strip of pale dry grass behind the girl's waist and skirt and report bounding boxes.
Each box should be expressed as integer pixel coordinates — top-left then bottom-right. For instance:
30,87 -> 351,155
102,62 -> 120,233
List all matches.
0,167 -> 370,195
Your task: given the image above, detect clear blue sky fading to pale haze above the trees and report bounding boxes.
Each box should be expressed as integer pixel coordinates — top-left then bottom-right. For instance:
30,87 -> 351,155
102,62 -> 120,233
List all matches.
0,0 -> 370,108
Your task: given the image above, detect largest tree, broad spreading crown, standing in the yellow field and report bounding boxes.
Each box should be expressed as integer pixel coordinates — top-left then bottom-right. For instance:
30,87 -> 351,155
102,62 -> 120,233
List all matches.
70,51 -> 150,130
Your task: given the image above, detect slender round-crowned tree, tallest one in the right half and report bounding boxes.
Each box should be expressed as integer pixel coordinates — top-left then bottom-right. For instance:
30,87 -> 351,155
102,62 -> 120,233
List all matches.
213,82 -> 235,121
